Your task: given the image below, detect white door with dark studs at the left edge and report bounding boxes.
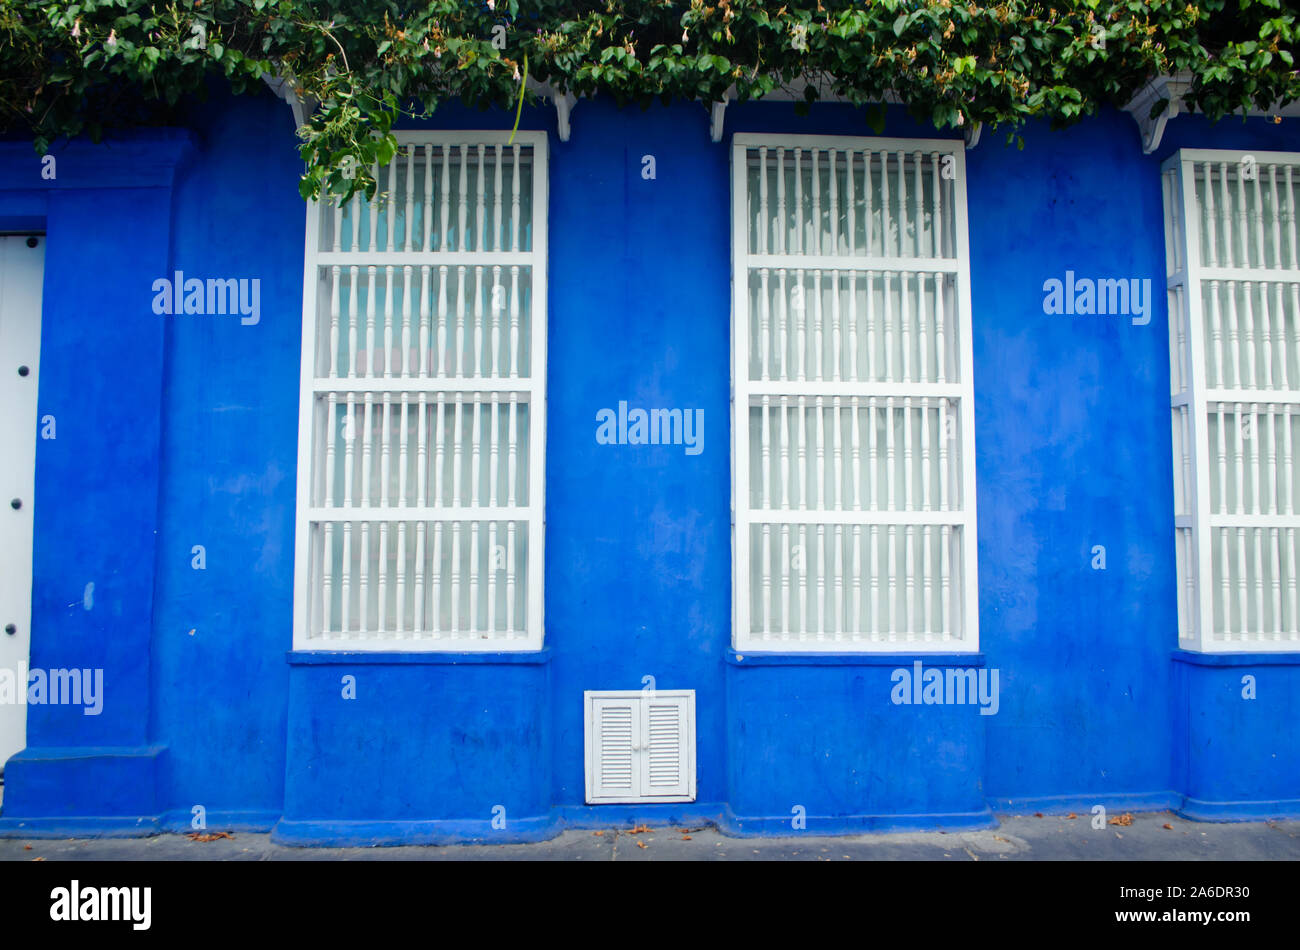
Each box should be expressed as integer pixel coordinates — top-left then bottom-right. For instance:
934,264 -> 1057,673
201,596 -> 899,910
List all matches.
0,235 -> 46,771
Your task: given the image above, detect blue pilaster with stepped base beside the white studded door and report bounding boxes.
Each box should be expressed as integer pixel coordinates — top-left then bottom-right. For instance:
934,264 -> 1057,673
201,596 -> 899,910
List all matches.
0,130 -> 192,834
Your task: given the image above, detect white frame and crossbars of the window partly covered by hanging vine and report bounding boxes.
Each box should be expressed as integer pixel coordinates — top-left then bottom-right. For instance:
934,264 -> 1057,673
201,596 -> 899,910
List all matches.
294,130 -> 550,652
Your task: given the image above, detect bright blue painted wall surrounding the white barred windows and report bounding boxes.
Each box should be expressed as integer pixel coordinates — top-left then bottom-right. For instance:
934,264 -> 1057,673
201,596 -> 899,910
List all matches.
0,83 -> 1300,843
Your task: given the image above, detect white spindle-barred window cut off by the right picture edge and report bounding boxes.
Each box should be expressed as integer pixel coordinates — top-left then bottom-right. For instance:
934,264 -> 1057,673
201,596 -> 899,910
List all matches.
1162,149 -> 1300,652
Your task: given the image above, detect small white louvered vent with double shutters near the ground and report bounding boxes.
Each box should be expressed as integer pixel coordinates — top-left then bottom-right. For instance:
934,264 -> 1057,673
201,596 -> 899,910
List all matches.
585,690 -> 696,804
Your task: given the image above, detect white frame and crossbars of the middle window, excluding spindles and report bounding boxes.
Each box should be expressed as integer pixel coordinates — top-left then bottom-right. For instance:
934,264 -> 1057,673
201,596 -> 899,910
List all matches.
731,133 -> 979,654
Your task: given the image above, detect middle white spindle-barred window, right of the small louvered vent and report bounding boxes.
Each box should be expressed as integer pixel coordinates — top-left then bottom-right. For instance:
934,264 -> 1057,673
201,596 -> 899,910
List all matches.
732,135 -> 979,652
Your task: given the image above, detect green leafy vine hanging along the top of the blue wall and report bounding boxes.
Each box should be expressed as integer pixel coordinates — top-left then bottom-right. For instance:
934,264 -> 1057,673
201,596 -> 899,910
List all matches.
0,0 -> 1300,196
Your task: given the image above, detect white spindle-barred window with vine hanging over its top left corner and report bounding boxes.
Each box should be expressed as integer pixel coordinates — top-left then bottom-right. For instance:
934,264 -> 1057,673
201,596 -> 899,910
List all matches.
294,133 -> 546,651
